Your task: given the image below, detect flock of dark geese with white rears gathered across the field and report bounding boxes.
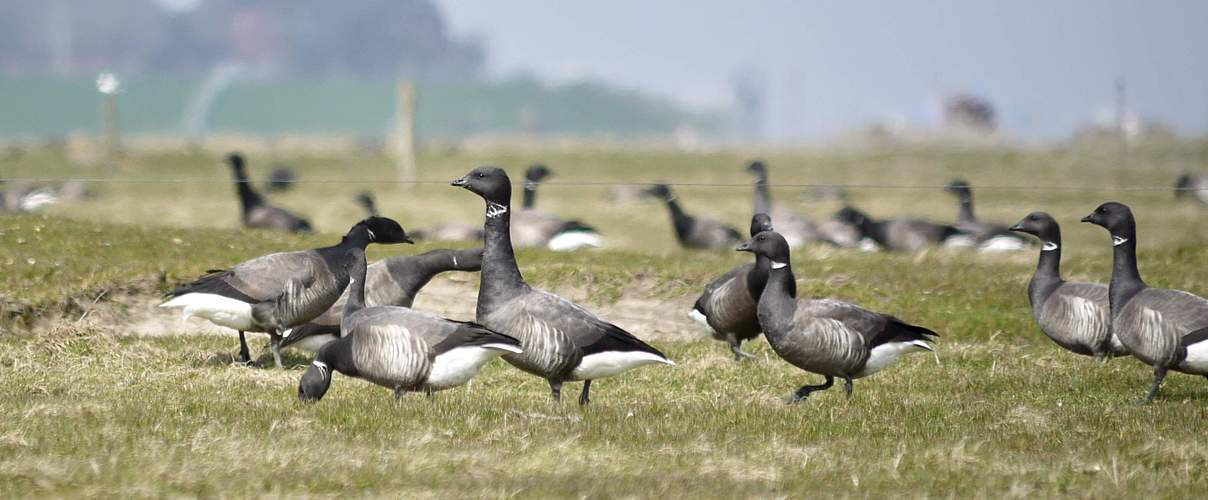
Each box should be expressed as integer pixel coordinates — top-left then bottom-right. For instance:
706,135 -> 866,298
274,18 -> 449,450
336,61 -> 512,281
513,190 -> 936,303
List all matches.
161,155 -> 1208,405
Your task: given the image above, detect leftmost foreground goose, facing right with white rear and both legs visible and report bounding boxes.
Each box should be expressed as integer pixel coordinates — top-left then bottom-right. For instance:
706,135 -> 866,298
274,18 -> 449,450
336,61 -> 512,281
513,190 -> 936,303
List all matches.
159,217 -> 411,367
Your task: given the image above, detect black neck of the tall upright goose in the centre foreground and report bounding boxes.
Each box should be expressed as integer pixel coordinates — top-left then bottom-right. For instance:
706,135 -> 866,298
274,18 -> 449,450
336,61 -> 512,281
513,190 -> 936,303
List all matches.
478,196 -> 525,316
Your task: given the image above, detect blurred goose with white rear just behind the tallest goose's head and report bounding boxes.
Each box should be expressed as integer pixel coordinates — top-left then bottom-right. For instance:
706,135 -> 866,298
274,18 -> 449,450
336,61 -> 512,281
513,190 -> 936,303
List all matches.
512,165 -> 604,251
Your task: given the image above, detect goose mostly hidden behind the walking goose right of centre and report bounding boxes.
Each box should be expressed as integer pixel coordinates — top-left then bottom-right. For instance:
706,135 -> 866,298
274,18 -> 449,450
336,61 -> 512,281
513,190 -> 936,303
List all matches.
687,214 -> 772,361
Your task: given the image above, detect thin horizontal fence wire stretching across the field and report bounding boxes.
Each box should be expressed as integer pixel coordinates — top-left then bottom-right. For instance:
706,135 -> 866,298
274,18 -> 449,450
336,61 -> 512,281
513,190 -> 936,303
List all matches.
0,178 -> 1193,192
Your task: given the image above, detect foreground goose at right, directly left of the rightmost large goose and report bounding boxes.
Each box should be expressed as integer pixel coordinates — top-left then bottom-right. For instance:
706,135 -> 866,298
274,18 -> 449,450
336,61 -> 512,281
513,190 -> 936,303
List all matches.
1011,211 -> 1128,362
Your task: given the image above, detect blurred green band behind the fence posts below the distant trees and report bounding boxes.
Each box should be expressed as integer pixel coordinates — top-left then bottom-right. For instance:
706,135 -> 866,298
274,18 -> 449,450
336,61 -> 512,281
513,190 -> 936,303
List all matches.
0,77 -> 722,139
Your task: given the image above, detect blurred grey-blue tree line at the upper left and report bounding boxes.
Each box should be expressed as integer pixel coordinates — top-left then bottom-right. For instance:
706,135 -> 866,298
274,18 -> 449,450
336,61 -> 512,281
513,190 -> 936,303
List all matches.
0,0 -> 486,80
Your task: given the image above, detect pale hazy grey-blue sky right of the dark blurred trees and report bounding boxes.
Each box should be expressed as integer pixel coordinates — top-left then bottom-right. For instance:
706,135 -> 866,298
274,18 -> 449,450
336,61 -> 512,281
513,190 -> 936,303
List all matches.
439,0 -> 1208,139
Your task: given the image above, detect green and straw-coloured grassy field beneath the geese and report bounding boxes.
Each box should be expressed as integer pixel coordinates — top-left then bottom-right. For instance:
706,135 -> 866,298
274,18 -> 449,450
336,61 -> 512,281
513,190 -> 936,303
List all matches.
0,146 -> 1208,498
